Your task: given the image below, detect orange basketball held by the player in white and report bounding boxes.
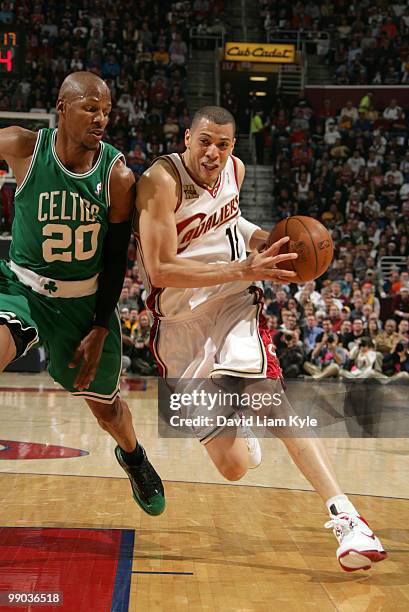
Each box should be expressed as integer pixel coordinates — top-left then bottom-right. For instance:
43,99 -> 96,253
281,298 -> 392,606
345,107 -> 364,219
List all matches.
267,215 -> 334,283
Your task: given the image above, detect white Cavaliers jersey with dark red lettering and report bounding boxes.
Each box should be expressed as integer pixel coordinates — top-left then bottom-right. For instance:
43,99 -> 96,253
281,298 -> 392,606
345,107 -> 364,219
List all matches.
138,153 -> 250,320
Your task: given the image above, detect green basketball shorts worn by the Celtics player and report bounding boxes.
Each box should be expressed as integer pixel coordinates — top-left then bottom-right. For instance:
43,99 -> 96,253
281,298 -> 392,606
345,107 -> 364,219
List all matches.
0,261 -> 122,404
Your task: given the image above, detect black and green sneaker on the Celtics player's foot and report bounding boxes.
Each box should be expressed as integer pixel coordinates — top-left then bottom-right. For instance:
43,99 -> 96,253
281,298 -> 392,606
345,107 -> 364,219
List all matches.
115,446 -> 166,516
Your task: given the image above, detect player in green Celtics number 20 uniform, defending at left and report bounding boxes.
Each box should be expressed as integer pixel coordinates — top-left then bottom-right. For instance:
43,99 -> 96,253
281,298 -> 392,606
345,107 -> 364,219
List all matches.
0,72 -> 165,515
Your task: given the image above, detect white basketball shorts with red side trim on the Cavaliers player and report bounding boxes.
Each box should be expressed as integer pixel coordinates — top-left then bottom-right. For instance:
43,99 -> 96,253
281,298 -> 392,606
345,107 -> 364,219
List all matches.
151,287 -> 282,442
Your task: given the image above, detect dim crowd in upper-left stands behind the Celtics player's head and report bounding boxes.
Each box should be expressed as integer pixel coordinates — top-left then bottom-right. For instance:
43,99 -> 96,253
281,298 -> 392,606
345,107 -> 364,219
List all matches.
0,0 -> 223,175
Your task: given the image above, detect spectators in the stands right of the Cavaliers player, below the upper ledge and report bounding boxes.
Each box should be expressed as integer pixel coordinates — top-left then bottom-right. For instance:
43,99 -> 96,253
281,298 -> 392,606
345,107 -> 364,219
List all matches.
265,92 -> 409,379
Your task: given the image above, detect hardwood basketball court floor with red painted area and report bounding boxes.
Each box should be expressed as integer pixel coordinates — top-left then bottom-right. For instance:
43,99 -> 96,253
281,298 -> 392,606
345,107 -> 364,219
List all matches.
0,373 -> 409,612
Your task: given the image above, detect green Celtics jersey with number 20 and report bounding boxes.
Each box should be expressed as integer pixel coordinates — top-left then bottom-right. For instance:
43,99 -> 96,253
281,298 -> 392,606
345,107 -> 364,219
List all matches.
10,129 -> 122,280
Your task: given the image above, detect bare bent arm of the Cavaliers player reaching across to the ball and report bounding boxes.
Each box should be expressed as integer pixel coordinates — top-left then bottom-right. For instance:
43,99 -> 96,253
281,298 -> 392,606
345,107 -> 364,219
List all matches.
136,163 -> 297,288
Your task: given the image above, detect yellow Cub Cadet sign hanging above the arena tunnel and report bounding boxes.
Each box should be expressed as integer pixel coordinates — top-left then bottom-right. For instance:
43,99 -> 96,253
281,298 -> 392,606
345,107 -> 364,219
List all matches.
224,42 -> 295,64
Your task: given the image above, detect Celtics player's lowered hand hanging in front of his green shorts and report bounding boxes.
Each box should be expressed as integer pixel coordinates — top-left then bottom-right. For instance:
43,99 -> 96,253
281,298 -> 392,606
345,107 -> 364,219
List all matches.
68,327 -> 108,391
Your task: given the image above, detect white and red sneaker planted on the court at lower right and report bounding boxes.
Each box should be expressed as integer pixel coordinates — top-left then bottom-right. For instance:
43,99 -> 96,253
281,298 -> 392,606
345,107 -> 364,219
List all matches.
325,513 -> 388,572
